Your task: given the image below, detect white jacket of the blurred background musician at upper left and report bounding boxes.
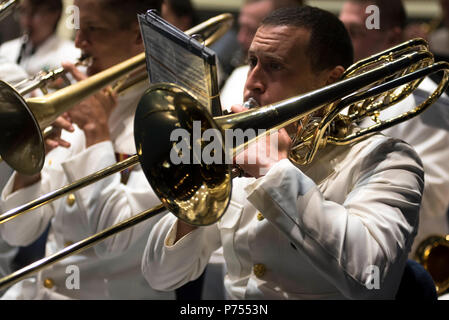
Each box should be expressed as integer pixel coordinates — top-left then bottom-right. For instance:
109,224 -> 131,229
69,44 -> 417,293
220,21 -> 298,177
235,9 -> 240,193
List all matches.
0,34 -> 81,76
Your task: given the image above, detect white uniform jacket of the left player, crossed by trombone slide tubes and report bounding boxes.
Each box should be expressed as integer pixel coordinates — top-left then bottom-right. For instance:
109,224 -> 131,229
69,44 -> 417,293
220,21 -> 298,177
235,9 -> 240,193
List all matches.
0,85 -> 174,299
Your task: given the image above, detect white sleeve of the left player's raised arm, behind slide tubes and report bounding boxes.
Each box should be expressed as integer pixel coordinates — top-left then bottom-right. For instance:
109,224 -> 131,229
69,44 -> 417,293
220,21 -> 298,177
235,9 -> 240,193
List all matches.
62,141 -> 160,256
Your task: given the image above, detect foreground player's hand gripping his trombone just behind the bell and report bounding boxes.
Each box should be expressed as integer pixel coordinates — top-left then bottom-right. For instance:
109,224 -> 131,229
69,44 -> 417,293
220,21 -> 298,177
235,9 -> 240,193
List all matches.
231,105 -> 292,178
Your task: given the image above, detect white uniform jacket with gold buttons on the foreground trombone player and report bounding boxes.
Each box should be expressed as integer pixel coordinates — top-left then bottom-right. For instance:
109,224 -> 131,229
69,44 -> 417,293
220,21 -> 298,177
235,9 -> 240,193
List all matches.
142,134 -> 424,299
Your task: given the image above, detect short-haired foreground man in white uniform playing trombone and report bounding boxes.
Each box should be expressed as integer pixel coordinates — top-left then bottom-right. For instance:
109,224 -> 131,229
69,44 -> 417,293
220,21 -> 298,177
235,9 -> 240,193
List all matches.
142,6 -> 424,299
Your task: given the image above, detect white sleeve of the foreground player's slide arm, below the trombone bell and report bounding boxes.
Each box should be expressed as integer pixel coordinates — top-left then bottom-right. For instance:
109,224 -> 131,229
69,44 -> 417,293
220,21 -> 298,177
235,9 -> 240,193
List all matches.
142,214 -> 220,291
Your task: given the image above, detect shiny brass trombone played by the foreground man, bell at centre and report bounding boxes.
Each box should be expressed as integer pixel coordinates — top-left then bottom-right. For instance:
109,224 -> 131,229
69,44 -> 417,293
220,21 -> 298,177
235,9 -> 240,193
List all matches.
0,37 -> 449,288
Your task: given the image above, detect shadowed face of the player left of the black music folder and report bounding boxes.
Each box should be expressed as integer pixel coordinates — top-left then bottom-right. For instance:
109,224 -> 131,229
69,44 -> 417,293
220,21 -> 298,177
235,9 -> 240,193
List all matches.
75,0 -> 143,75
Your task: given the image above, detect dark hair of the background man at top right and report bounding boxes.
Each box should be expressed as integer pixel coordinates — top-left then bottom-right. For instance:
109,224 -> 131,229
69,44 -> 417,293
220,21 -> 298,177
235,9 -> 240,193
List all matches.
349,0 -> 407,30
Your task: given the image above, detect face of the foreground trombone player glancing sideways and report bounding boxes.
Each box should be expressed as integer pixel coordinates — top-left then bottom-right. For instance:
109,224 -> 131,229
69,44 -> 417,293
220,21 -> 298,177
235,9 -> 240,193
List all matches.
244,26 -> 328,106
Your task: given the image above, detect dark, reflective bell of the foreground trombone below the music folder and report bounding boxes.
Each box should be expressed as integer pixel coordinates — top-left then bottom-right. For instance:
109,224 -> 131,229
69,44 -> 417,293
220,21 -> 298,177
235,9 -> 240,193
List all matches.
134,84 -> 231,226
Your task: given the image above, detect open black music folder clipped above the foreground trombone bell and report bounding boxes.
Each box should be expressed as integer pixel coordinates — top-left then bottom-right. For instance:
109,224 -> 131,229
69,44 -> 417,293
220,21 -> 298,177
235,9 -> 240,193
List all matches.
138,10 -> 222,116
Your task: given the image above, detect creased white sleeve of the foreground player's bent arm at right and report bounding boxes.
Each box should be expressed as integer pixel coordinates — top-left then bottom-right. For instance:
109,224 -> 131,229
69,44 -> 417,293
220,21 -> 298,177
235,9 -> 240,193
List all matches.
246,140 -> 424,299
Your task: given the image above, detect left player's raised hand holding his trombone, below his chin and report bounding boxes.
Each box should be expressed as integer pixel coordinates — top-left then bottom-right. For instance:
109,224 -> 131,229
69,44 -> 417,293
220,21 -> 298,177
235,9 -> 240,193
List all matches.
63,63 -> 117,147
